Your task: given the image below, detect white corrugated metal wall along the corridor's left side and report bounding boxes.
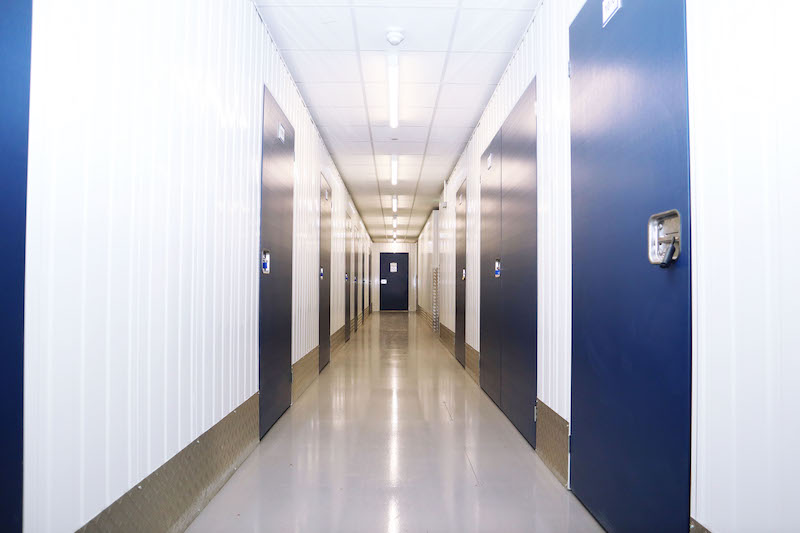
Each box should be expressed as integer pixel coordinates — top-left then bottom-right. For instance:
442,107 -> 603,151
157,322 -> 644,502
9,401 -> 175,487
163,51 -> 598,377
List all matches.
24,0 -> 368,531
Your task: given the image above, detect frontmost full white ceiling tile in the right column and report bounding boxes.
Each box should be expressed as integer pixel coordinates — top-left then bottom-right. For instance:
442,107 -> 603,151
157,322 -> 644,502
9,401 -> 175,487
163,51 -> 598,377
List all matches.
452,9 -> 533,52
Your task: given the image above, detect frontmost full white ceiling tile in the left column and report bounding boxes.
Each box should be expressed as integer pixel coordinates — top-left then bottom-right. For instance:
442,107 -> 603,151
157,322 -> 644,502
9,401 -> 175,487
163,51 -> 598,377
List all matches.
258,5 -> 355,50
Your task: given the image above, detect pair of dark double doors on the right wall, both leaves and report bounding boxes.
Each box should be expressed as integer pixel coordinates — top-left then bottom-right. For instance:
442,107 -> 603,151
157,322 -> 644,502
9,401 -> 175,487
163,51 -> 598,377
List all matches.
480,79 -> 537,446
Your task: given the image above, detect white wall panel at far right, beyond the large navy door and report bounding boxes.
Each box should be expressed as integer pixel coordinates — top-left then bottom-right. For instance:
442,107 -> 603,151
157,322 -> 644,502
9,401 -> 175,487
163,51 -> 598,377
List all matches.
687,0 -> 800,532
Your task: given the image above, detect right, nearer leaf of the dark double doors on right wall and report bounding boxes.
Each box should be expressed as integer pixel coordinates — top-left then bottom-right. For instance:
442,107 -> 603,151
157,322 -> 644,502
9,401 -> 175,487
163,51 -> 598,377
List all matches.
501,79 -> 537,446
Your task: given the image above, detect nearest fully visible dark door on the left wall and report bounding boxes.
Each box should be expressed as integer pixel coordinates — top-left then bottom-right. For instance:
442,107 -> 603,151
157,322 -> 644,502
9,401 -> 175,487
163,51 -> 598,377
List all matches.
258,87 -> 294,437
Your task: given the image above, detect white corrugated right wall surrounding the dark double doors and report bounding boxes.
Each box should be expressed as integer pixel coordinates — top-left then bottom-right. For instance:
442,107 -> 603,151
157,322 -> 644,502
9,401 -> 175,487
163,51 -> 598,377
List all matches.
443,0 -> 585,420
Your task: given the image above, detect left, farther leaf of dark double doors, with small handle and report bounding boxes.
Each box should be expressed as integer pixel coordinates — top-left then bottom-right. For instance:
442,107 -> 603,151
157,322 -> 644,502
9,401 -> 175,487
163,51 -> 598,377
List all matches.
480,130 -> 503,406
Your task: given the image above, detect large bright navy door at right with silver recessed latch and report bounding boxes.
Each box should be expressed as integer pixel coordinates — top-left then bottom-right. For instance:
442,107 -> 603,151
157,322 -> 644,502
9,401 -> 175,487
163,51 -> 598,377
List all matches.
570,0 -> 691,531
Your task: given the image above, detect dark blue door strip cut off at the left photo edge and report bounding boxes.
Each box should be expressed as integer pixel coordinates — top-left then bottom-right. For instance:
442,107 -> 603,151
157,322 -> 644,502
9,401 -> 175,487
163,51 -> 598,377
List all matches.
0,0 -> 32,531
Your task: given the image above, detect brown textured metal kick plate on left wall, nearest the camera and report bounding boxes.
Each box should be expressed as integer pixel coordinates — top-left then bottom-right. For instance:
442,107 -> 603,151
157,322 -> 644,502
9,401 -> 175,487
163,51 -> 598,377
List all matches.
78,394 -> 258,532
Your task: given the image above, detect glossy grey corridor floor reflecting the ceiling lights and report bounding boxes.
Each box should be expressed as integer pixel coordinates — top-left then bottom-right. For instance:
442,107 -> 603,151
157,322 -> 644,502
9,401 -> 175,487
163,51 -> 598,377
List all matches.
189,313 -> 602,533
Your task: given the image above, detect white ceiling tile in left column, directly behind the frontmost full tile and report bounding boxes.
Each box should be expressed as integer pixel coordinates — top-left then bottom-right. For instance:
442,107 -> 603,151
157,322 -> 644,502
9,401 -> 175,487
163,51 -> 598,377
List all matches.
282,50 -> 361,83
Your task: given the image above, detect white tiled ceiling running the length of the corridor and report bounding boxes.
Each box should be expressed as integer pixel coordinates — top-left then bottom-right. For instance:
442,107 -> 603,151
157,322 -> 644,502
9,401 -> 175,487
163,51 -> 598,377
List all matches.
255,0 -> 540,242
